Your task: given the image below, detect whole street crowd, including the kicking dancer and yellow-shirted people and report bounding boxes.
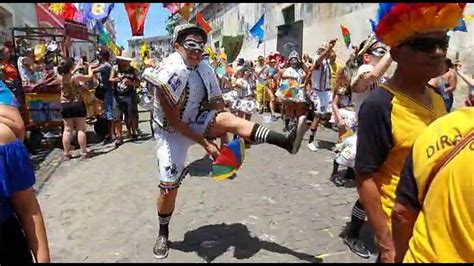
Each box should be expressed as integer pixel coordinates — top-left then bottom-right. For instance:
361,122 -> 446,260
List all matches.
0,3 -> 474,262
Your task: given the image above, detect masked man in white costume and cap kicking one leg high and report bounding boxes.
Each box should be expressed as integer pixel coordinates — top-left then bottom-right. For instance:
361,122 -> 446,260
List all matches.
145,24 -> 306,259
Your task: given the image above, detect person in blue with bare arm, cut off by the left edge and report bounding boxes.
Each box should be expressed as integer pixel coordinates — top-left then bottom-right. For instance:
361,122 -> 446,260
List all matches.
0,81 -> 50,264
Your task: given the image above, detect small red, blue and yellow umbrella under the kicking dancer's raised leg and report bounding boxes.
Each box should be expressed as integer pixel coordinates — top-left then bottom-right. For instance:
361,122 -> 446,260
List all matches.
212,138 -> 245,180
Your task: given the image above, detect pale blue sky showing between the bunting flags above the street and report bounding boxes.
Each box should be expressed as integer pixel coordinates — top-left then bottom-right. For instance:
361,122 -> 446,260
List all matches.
111,3 -> 170,49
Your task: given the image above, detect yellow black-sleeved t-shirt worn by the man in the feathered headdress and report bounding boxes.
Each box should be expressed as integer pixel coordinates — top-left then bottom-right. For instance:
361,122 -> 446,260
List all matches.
355,84 -> 446,230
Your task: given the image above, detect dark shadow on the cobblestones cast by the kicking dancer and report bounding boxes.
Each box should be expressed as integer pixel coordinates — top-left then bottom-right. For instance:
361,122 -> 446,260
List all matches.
170,223 -> 322,263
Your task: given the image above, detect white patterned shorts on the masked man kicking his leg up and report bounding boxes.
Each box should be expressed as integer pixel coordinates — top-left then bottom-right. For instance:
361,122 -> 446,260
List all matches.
154,110 -> 218,189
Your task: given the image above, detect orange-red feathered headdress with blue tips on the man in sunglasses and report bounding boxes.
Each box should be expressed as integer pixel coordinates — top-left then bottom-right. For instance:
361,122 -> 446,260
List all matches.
371,3 -> 466,47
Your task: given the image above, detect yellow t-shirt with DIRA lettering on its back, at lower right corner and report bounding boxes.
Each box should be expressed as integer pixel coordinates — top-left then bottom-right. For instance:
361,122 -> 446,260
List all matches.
397,107 -> 474,262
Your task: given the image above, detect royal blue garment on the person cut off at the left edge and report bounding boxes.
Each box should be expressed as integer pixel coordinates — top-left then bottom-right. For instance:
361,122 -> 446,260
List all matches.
0,140 -> 35,222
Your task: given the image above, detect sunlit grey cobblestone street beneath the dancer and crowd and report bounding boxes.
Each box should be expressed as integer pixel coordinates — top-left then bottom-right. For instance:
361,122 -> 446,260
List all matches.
36,111 -> 375,262
